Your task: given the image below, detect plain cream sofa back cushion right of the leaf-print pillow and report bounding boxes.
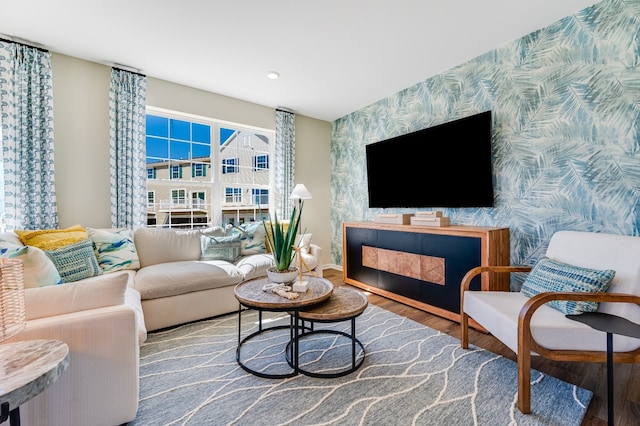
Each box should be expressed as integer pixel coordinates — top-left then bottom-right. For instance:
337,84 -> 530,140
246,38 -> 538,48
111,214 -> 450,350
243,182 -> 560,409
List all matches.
133,228 -> 200,268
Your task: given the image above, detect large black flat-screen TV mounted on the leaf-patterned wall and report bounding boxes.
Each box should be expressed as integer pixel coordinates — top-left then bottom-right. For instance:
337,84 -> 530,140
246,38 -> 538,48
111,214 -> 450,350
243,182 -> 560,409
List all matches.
366,111 -> 493,208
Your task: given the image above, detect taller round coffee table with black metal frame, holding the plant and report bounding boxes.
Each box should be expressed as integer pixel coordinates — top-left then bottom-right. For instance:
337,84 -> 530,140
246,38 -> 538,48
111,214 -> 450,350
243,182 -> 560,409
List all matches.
234,277 -> 333,379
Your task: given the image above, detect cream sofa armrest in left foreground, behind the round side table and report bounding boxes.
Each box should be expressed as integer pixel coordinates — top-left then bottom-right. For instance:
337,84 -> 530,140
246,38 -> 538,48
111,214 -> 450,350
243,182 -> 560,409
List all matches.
3,305 -> 139,426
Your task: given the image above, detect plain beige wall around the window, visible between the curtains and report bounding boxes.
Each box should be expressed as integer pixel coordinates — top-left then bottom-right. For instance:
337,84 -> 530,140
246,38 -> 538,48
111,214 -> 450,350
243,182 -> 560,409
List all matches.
52,53 -> 331,264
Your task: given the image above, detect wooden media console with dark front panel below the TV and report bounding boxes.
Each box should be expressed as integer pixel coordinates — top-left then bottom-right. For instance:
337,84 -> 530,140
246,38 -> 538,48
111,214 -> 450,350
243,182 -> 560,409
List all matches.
342,222 -> 510,321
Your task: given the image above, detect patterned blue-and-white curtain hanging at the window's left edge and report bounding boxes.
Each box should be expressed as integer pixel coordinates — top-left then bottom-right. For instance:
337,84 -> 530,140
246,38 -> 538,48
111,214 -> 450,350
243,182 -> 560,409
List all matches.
109,68 -> 147,229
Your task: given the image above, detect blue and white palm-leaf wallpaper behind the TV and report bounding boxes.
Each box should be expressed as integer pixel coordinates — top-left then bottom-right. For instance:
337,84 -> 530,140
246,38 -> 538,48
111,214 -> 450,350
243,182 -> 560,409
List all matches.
331,0 -> 640,288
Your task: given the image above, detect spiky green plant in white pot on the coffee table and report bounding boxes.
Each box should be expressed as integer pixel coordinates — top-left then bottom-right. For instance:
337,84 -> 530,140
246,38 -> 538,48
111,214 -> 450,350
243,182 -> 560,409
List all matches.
262,204 -> 302,283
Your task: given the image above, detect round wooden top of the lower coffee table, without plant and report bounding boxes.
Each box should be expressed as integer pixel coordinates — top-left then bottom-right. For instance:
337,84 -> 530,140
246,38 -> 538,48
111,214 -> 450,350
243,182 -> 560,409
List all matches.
298,287 -> 369,322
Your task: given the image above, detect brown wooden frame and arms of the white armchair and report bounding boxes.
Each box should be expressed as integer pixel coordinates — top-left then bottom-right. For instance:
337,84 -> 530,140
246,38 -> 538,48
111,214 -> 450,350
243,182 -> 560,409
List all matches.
460,266 -> 640,414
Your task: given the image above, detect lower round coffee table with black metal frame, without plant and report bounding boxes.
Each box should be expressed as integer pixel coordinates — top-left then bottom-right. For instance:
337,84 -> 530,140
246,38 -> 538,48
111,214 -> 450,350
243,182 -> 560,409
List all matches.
286,287 -> 369,378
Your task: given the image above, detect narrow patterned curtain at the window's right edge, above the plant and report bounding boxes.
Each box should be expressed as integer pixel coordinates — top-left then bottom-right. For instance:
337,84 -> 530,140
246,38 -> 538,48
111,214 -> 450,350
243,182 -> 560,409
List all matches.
275,109 -> 296,220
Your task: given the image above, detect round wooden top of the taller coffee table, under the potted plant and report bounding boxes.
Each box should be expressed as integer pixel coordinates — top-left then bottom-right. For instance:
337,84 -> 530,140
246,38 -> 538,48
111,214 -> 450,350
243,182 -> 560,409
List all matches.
234,277 -> 334,310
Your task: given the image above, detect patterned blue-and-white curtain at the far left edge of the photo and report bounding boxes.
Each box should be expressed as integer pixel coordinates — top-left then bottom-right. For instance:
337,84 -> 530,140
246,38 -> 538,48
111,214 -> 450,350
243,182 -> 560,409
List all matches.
0,40 -> 58,230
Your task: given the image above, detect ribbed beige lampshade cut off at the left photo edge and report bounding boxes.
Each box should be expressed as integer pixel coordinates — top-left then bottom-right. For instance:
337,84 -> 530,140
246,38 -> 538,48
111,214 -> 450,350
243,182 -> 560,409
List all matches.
0,258 -> 27,342
